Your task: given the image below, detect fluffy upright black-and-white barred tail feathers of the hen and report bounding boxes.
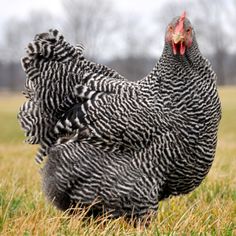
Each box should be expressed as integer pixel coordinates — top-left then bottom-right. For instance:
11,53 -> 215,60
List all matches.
18,30 -> 125,162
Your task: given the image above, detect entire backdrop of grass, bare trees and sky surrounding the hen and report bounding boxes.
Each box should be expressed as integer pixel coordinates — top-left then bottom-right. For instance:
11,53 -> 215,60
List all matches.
0,0 -> 236,236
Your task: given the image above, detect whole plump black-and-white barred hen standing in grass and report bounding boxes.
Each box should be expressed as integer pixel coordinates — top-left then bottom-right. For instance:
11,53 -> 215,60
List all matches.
18,15 -> 221,220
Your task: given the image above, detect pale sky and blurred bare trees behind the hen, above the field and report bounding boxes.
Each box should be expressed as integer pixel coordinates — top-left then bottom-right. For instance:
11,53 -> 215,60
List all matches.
0,0 -> 236,91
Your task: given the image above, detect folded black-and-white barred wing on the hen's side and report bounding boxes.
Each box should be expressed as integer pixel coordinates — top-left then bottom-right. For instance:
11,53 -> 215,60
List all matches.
55,81 -> 164,150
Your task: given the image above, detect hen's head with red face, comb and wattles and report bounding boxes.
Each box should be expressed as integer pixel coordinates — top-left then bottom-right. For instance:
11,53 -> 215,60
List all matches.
165,12 -> 193,55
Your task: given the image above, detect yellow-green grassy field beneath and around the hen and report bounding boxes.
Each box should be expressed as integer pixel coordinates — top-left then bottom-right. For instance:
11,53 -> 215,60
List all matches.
0,87 -> 236,236
